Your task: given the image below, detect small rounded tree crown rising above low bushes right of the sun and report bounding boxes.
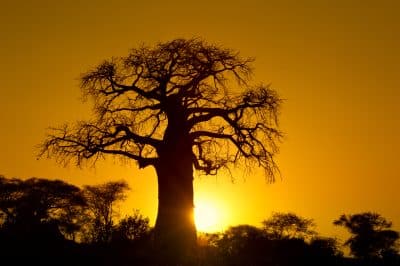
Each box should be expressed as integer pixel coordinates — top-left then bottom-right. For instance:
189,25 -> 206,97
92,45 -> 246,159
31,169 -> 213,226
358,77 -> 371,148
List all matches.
262,212 -> 316,239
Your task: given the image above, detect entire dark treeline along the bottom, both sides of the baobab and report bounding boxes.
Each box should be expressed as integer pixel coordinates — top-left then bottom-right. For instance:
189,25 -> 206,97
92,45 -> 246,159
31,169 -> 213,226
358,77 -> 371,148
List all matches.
0,176 -> 400,266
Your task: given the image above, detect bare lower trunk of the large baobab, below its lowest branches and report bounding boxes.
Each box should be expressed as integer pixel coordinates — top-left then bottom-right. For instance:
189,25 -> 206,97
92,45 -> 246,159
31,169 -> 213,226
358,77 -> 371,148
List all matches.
155,156 -> 196,260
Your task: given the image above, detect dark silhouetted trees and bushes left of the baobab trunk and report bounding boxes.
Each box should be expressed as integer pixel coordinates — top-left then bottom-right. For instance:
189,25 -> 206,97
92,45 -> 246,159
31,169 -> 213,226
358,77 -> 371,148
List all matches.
0,176 -> 150,265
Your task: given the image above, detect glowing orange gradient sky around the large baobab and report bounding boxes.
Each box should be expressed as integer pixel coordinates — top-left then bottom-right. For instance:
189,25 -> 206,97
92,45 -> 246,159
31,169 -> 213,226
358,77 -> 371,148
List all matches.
0,0 -> 400,239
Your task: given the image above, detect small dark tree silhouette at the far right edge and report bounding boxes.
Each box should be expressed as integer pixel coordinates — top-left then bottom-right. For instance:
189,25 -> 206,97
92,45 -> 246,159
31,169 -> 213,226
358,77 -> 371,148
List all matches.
334,212 -> 399,259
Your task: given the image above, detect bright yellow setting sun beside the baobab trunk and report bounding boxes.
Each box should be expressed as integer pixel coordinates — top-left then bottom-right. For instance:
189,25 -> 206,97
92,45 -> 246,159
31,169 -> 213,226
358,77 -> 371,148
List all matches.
194,198 -> 221,232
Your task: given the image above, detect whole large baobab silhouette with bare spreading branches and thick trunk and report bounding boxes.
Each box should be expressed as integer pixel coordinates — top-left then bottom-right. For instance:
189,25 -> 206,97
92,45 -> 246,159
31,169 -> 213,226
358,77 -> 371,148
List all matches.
40,39 -> 281,258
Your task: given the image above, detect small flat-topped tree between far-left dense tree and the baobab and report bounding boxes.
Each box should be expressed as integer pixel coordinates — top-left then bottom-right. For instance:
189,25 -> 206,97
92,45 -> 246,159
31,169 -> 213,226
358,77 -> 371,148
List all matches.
83,181 -> 129,243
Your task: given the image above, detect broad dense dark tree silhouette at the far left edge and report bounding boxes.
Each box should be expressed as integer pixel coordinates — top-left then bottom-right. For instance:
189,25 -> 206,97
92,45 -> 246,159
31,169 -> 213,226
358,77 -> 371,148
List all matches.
0,177 -> 86,243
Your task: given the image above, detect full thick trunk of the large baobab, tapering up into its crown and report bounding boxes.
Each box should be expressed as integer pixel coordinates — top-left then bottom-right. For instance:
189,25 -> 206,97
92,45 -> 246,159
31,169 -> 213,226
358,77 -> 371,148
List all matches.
154,102 -> 196,262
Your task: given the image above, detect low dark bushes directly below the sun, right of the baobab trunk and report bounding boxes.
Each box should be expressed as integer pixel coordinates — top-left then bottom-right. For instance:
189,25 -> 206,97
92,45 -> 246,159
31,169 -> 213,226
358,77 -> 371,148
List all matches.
203,225 -> 344,266
